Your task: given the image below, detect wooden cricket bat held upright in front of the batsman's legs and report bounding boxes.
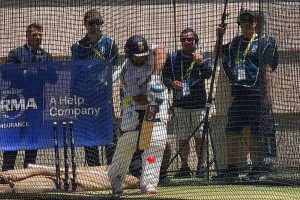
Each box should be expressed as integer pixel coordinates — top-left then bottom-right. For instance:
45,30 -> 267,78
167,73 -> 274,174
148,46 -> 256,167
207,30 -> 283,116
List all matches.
139,105 -> 159,150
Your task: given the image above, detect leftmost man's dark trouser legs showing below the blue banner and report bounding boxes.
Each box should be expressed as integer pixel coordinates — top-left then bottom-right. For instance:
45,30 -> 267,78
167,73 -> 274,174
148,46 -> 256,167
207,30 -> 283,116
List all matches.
2,150 -> 37,171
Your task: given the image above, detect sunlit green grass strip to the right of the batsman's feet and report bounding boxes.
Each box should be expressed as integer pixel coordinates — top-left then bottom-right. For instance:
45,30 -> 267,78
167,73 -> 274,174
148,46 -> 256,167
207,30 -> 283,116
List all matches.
124,185 -> 300,200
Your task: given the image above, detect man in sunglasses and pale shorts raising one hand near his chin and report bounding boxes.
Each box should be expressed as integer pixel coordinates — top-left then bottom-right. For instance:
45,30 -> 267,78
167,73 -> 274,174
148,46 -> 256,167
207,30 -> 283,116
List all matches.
163,28 -> 212,178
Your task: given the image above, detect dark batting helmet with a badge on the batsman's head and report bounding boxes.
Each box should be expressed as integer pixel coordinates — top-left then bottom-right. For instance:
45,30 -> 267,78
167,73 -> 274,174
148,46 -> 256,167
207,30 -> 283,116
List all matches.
124,35 -> 149,57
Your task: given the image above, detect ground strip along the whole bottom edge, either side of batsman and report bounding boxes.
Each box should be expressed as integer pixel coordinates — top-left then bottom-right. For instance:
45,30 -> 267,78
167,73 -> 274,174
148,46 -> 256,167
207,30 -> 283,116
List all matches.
0,185 -> 300,200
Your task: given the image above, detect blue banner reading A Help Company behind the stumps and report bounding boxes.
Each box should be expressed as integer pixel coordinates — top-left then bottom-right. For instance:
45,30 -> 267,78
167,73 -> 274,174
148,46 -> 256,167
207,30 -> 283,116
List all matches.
0,59 -> 113,150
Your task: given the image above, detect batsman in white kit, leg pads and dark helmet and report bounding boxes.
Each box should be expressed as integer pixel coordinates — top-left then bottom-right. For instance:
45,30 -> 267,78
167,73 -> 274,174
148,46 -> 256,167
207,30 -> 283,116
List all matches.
108,35 -> 168,196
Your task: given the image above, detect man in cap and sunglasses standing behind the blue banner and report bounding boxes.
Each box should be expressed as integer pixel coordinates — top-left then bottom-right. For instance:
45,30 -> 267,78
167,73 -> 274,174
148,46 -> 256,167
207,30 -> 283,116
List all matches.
71,9 -> 118,166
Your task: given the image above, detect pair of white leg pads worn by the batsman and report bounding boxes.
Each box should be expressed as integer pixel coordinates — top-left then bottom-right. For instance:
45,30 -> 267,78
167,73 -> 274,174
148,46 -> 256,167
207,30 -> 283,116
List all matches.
108,122 -> 167,188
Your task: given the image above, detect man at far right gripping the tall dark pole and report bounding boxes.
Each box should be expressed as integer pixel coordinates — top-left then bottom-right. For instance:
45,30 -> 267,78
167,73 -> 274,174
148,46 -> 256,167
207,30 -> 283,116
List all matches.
217,10 -> 278,178
